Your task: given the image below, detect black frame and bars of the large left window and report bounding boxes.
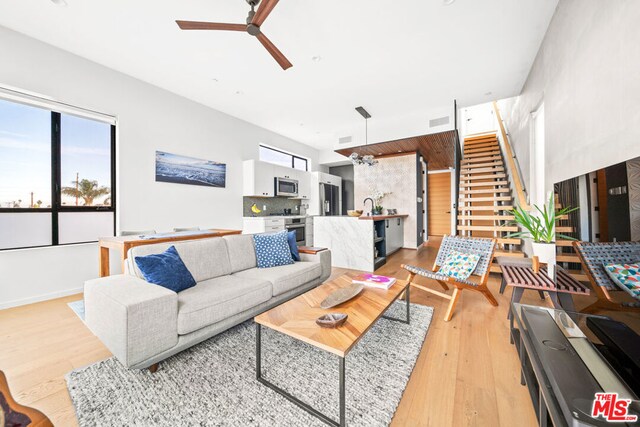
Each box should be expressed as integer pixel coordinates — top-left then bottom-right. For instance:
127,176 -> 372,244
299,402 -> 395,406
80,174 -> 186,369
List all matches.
0,107 -> 117,252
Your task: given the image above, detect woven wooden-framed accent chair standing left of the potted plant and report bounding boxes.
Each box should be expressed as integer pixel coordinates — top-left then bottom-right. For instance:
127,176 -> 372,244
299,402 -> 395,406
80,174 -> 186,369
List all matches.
402,236 -> 498,322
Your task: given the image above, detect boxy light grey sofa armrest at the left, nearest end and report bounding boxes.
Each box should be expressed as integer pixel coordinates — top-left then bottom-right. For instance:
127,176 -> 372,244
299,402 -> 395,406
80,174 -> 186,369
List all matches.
84,274 -> 178,367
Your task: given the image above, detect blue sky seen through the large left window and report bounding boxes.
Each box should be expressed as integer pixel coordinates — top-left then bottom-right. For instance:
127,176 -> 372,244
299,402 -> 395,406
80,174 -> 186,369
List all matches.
0,99 -> 111,207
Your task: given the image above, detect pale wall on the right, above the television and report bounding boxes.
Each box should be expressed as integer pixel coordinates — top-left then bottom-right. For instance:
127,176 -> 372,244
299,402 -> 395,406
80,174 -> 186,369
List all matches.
499,0 -> 640,199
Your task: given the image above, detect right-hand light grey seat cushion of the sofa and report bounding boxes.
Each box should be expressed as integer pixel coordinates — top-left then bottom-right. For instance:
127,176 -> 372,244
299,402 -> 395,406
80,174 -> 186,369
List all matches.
233,261 -> 322,296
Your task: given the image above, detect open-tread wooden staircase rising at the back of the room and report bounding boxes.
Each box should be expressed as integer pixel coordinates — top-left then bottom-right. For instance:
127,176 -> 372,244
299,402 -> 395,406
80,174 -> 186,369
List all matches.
457,133 -> 524,273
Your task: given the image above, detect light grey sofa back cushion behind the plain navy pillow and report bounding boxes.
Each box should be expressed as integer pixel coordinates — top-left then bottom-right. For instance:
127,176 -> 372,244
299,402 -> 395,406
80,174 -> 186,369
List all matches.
129,237 -> 231,282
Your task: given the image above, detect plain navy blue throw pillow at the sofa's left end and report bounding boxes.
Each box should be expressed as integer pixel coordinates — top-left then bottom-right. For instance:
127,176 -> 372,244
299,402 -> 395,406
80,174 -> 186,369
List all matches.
135,246 -> 196,292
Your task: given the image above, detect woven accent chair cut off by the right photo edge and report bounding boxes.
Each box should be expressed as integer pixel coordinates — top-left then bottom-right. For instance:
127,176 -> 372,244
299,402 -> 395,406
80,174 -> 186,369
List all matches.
573,242 -> 640,313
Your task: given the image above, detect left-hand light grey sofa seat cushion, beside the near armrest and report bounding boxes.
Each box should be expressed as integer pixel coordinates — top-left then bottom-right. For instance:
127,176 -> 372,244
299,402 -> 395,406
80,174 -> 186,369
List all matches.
178,276 -> 272,335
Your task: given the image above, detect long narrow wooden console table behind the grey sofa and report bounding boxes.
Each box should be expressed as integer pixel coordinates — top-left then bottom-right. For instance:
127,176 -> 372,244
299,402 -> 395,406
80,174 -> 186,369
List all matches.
98,229 -> 242,277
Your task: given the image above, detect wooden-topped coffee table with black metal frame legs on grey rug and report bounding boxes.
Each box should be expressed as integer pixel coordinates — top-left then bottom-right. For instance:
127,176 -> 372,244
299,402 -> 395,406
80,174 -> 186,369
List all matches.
254,273 -> 410,426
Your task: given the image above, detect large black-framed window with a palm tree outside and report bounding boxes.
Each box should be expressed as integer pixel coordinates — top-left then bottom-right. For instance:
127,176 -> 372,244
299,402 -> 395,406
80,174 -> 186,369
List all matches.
0,99 -> 115,249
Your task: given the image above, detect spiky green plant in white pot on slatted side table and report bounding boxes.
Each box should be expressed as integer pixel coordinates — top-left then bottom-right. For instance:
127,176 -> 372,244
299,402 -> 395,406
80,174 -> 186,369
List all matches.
507,193 -> 578,264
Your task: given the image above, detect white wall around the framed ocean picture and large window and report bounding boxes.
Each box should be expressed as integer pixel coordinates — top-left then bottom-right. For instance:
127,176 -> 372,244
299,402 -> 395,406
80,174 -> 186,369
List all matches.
0,27 -> 318,308
